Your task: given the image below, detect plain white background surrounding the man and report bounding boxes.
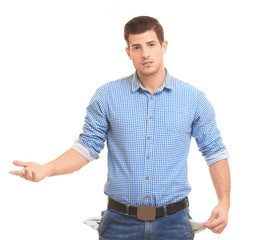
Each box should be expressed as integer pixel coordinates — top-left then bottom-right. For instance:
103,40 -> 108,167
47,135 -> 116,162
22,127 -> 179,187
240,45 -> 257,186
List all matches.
0,0 -> 258,240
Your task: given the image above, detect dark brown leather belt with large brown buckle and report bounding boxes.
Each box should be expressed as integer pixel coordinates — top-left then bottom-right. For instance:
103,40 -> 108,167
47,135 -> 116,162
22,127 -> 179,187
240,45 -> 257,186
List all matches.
108,197 -> 189,221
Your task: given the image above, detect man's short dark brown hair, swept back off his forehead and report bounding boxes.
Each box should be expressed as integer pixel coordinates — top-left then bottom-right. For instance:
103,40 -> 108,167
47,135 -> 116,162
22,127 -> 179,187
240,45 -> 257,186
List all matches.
124,16 -> 164,44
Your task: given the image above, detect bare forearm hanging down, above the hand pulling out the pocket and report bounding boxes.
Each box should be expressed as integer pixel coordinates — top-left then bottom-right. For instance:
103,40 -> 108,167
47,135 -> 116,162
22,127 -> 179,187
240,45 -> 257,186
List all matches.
210,159 -> 231,207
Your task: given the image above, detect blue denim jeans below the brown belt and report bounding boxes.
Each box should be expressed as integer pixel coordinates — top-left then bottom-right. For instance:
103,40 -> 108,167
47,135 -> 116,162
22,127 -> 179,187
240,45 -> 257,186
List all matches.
98,208 -> 194,240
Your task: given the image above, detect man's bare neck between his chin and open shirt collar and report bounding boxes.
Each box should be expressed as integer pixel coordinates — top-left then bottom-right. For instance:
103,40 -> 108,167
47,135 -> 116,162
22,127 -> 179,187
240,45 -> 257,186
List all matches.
137,67 -> 166,94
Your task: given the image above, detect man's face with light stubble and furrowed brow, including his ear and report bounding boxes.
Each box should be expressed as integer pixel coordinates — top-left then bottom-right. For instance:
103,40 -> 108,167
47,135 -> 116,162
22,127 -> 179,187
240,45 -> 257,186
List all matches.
126,30 -> 168,76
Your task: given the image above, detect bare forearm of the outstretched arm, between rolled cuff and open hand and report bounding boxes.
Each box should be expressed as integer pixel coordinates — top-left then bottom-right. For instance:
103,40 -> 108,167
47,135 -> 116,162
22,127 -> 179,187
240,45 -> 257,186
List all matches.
44,148 -> 89,177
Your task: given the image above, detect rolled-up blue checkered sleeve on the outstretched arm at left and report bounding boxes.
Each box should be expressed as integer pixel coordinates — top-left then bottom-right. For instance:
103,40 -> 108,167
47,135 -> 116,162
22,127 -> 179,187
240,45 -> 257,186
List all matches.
72,85 -> 108,161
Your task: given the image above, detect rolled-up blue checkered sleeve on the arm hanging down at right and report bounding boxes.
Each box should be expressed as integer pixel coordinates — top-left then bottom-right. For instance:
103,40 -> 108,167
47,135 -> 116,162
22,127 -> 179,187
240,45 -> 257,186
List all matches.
192,92 -> 229,166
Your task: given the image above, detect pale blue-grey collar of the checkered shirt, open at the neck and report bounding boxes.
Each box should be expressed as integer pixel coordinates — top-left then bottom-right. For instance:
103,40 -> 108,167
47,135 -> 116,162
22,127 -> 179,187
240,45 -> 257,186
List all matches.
132,70 -> 174,93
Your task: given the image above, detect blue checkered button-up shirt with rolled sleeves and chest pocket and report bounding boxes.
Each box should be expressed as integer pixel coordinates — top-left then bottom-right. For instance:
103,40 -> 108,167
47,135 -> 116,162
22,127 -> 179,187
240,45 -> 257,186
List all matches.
72,72 -> 228,206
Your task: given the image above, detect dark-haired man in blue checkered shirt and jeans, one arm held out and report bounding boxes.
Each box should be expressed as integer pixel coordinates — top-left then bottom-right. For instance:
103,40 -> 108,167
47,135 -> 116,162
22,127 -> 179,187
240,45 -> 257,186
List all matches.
11,16 -> 230,240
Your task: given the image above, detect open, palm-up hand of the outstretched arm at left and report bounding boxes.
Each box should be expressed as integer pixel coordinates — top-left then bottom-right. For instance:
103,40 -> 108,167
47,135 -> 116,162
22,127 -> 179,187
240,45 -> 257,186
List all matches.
10,161 -> 47,182
